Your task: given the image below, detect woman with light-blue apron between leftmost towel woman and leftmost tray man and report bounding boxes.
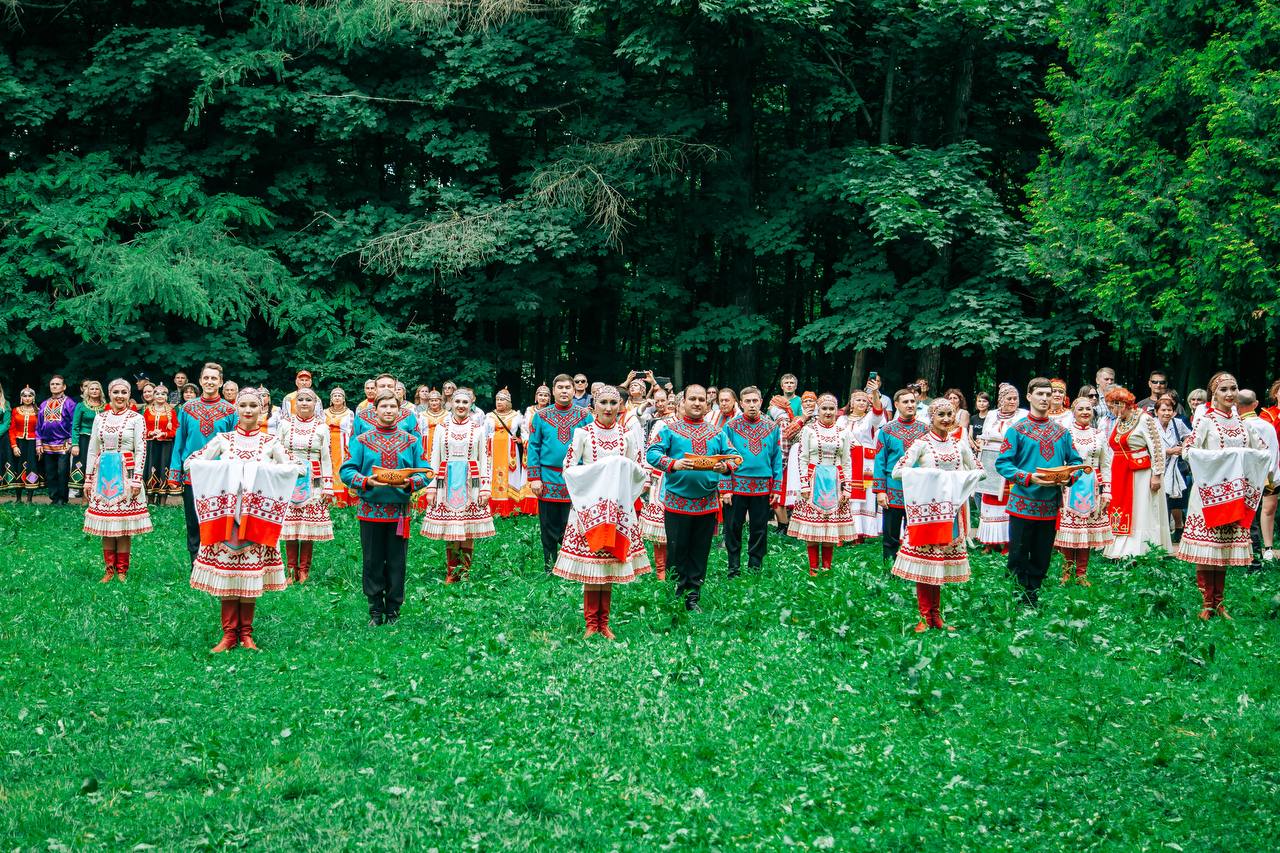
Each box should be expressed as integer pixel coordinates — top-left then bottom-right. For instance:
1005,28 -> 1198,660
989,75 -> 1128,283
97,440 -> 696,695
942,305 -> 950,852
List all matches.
279,388 -> 333,584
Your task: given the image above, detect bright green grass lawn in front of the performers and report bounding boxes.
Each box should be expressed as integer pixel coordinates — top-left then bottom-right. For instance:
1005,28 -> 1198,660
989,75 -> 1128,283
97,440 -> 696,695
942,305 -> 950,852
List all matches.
0,502 -> 1280,850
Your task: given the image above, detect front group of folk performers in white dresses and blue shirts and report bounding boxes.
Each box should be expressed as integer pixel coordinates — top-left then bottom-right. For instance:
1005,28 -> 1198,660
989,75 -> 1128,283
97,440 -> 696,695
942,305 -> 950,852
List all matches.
52,364 -> 1275,652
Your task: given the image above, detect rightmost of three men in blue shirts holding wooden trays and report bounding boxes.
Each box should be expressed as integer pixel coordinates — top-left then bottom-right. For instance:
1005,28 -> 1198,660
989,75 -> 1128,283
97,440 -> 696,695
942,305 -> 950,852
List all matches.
996,377 -> 1083,607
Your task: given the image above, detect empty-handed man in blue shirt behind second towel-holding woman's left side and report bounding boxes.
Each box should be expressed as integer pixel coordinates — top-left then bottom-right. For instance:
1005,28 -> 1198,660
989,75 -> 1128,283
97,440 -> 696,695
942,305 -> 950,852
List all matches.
529,373 -> 591,574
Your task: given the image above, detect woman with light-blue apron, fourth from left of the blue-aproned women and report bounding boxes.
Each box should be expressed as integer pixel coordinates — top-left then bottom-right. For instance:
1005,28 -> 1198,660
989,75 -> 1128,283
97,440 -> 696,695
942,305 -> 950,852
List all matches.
787,392 -> 859,576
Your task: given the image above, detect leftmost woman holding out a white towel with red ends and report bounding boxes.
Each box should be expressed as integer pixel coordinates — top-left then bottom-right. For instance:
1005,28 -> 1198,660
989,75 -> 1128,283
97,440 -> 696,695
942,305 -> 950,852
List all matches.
183,388 -> 302,653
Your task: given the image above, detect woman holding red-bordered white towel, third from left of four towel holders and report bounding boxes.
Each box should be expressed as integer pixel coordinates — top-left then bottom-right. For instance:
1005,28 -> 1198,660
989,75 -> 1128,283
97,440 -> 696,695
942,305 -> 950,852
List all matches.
892,397 -> 982,633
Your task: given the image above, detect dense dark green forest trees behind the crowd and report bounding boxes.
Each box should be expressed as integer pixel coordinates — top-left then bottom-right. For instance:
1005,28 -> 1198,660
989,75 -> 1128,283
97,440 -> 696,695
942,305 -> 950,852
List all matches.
0,0 -> 1280,400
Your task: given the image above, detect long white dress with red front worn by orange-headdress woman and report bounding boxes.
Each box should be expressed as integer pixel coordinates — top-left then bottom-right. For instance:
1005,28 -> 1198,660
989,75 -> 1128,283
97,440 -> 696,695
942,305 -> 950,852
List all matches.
1102,411 -> 1174,560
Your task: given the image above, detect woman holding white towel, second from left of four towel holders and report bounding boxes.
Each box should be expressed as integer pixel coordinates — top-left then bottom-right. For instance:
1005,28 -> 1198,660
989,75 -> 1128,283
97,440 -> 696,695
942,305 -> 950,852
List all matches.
552,386 -> 649,630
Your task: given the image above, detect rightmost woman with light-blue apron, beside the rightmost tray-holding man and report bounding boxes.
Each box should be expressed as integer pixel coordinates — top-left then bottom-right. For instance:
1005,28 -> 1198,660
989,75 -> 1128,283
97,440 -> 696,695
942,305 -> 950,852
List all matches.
1053,397 -> 1115,587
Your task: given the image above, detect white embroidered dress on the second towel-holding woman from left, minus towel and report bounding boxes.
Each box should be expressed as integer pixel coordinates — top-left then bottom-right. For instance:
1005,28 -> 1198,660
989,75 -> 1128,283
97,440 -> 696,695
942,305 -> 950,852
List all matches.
552,421 -> 649,584
